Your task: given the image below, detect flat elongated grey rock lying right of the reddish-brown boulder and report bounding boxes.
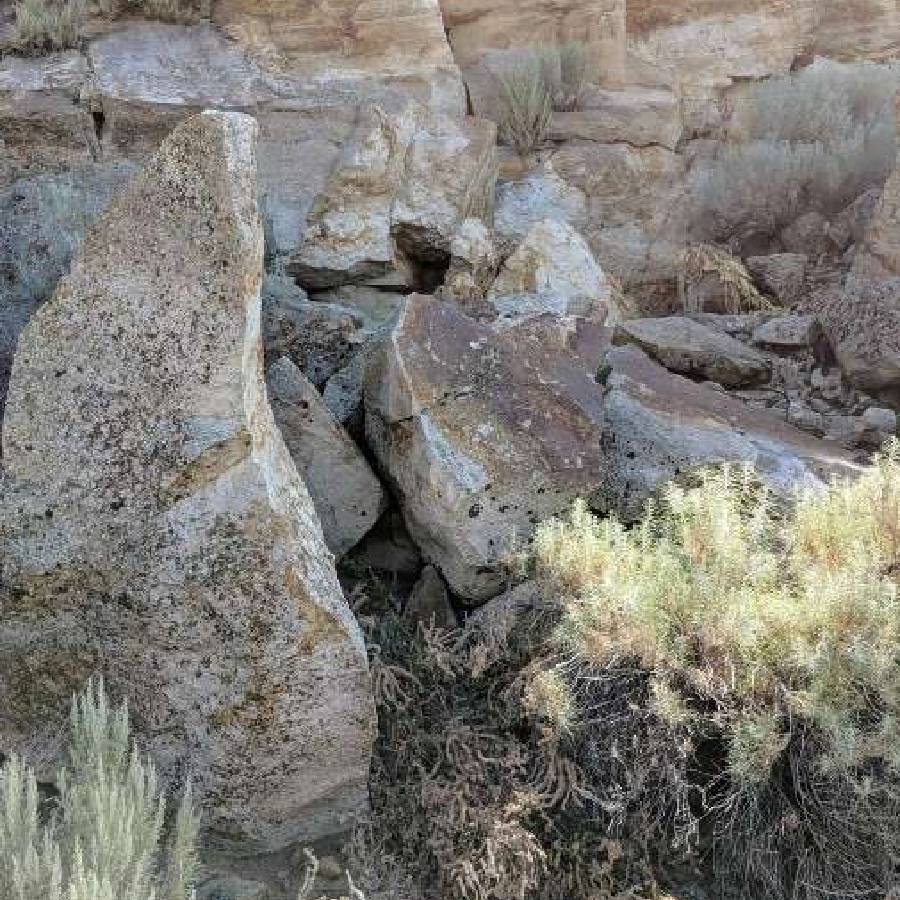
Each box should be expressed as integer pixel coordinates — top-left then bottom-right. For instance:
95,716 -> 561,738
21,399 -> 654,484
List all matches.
613,316 -> 770,387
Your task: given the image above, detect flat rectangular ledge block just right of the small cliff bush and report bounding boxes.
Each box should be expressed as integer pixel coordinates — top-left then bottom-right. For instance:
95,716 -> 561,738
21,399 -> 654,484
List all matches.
550,87 -> 682,150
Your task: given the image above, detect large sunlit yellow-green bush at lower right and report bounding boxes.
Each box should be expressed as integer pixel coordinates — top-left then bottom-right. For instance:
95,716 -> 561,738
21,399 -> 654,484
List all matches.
535,442 -> 900,900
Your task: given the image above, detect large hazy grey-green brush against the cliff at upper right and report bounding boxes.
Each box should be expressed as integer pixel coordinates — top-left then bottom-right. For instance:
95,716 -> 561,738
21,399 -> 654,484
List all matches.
693,60 -> 897,240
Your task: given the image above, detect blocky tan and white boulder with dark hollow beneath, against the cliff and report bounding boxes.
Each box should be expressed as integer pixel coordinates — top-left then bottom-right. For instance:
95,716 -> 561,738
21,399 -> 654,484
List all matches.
287,103 -> 497,290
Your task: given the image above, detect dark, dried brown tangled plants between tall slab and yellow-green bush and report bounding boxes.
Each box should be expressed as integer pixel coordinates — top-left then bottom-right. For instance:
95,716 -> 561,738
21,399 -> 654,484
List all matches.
360,601 -> 695,900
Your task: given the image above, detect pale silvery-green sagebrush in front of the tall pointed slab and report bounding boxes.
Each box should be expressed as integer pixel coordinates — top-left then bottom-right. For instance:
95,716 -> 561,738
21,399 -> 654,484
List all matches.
0,680 -> 198,900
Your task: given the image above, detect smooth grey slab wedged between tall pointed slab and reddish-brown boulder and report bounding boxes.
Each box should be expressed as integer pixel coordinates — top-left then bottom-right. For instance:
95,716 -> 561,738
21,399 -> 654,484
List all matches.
266,356 -> 387,558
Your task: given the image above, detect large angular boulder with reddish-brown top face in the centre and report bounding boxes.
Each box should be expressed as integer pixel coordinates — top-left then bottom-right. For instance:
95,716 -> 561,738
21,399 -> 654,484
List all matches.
366,295 -> 602,602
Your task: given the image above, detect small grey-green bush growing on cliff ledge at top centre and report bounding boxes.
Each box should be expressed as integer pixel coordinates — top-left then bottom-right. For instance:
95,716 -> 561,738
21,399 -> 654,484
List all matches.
497,41 -> 591,158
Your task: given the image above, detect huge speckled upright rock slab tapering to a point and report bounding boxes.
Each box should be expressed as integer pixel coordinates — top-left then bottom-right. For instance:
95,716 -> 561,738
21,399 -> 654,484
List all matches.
0,113 -> 373,853
